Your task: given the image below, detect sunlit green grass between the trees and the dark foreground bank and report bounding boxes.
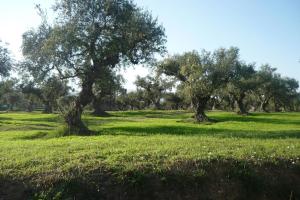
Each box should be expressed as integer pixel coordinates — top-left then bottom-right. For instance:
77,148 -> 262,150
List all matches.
0,111 -> 300,180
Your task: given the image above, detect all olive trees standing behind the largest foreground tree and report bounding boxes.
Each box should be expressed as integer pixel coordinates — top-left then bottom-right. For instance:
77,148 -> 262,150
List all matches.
0,44 -> 300,121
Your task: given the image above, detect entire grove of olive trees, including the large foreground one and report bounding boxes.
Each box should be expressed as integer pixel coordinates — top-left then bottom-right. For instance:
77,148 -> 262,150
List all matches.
0,0 -> 299,134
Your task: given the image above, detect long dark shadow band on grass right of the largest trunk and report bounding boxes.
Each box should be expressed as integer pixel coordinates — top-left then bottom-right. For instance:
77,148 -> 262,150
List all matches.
104,126 -> 300,139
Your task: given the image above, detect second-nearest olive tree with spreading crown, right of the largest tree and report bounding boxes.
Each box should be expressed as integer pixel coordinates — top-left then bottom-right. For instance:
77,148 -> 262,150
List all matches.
158,47 -> 239,122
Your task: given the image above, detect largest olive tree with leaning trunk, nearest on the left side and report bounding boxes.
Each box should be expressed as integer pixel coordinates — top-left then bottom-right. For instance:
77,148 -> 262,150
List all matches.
23,0 -> 166,134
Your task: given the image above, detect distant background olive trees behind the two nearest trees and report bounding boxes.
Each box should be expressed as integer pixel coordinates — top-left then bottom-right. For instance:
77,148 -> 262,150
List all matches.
0,58 -> 300,116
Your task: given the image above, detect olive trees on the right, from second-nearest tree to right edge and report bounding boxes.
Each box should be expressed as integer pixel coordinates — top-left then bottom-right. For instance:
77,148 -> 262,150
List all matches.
158,47 -> 299,121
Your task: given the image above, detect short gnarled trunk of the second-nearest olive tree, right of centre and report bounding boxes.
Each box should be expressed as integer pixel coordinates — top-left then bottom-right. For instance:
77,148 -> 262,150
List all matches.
192,97 -> 210,122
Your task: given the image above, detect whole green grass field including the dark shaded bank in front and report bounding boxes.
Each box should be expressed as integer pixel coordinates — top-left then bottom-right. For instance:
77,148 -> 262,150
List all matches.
0,111 -> 300,199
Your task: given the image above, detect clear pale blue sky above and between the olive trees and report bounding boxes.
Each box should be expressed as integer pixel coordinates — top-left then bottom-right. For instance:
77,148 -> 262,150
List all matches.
0,0 -> 300,88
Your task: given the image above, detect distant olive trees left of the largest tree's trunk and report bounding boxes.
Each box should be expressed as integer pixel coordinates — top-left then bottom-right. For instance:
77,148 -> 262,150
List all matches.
0,77 -> 69,113
